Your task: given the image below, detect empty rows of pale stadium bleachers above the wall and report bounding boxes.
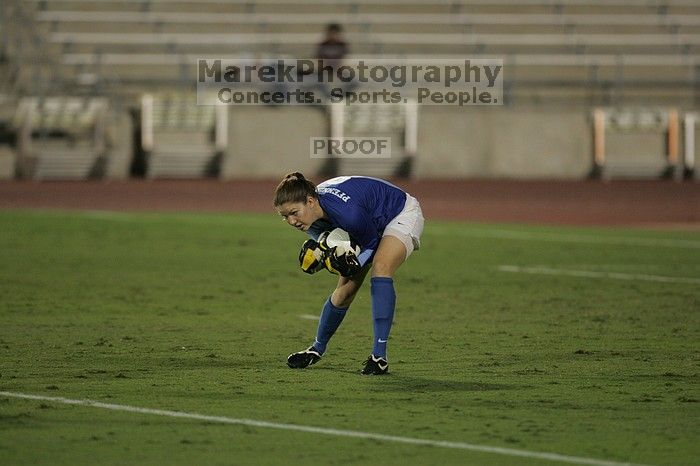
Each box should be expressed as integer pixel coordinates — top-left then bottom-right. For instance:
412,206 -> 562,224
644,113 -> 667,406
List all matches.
0,0 -> 700,176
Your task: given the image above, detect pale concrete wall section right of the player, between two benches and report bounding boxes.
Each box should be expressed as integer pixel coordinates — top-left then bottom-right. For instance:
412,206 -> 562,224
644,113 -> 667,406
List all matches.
416,106 -> 591,178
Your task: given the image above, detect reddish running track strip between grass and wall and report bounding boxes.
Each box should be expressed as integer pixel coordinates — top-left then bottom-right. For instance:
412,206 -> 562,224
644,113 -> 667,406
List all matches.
0,180 -> 700,229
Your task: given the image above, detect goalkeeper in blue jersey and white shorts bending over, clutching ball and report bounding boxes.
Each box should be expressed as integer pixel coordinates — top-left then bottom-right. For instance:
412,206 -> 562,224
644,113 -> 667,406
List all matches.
274,172 -> 423,375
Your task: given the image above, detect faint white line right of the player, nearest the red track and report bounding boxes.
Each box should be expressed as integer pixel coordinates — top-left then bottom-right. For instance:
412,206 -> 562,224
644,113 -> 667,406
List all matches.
428,227 -> 700,249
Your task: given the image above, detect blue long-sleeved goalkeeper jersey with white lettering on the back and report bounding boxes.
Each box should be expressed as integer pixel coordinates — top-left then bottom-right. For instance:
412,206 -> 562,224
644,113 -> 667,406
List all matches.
308,176 -> 406,265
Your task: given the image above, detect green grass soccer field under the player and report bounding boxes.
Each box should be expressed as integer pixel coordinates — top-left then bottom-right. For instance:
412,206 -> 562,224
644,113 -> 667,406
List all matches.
0,211 -> 700,466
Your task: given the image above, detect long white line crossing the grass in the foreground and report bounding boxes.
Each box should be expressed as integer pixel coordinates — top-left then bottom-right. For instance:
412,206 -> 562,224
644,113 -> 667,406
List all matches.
0,391 -> 643,466
